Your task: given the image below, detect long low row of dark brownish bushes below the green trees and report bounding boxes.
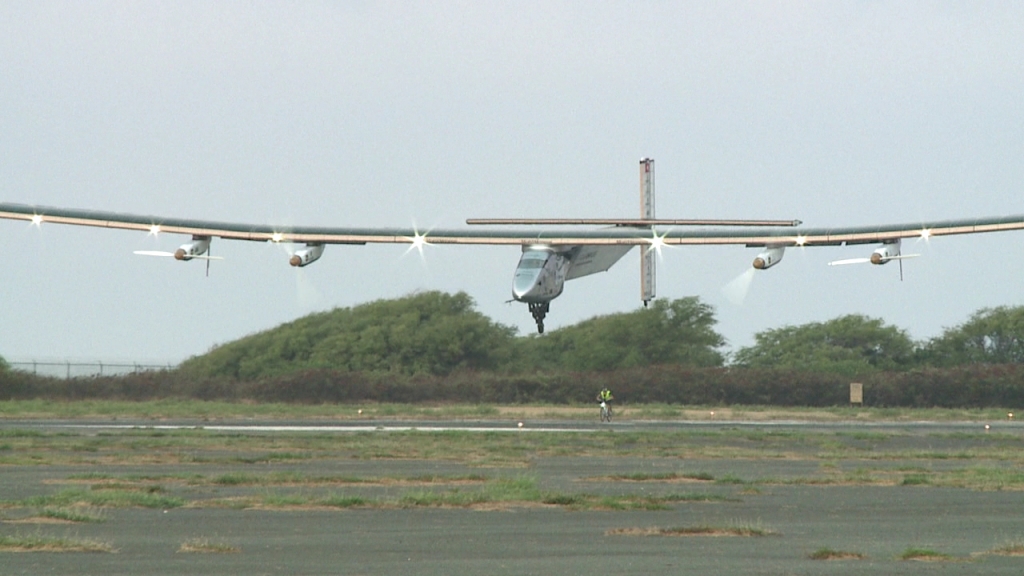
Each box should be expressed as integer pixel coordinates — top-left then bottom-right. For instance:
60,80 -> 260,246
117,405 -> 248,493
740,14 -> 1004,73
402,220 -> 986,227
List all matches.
6,364 -> 1024,408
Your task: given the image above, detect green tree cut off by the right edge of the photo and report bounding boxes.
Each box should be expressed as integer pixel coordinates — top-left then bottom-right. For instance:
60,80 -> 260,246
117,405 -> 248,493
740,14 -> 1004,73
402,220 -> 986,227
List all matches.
921,306 -> 1024,366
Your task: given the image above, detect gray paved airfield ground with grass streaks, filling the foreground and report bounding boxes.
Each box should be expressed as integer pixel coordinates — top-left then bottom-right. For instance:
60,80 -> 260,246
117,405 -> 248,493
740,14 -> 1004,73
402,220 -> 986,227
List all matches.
0,419 -> 1024,576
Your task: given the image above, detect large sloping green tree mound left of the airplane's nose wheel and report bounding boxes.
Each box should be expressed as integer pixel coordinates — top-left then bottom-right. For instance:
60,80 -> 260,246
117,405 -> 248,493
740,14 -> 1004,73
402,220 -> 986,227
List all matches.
181,292 -> 515,380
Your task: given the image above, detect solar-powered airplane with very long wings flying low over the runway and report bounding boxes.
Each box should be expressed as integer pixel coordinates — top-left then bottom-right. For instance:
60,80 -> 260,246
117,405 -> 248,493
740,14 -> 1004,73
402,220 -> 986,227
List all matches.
0,158 -> 1024,333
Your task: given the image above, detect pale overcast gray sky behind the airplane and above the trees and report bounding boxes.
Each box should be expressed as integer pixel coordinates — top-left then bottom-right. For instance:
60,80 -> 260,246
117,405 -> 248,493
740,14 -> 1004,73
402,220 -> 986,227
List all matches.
0,0 -> 1024,362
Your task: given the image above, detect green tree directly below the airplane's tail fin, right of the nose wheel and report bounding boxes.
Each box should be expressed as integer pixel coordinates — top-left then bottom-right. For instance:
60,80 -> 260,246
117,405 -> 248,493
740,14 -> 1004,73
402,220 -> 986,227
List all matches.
517,296 -> 725,371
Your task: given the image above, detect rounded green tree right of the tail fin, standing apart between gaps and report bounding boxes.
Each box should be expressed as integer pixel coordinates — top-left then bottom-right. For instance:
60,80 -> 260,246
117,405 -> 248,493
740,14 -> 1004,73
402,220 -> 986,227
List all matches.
733,315 -> 914,375
